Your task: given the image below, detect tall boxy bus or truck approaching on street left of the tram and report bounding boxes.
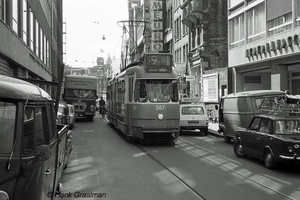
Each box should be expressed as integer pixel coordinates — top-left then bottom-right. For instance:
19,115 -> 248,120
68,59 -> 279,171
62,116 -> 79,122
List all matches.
63,75 -> 98,121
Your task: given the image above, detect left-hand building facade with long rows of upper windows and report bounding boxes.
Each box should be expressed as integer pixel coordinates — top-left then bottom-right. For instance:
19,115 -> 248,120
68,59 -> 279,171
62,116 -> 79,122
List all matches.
0,0 -> 63,94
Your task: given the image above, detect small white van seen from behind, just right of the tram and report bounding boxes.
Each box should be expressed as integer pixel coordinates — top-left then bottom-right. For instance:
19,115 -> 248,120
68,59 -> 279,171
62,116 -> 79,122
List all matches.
179,99 -> 208,135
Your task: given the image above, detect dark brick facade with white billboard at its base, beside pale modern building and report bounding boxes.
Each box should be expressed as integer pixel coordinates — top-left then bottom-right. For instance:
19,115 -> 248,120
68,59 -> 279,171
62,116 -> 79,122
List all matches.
180,0 -> 228,109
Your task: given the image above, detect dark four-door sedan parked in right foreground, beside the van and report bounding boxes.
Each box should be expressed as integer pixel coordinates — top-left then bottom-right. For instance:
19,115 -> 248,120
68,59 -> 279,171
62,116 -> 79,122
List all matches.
234,114 -> 300,169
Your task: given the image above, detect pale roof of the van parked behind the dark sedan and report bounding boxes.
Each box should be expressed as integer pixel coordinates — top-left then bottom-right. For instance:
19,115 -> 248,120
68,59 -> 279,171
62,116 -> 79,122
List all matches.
222,90 -> 285,98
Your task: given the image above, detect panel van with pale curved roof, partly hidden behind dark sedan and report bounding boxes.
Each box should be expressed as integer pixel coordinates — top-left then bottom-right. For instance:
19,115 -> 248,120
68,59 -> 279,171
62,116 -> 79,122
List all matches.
219,90 -> 286,143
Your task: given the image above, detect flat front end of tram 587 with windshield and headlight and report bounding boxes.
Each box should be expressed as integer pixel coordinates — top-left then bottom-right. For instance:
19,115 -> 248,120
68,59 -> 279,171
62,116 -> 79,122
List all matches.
131,55 -> 180,144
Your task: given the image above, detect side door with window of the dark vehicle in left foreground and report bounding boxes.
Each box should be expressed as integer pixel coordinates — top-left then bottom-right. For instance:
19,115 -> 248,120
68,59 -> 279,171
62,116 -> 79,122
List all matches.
16,105 -> 56,200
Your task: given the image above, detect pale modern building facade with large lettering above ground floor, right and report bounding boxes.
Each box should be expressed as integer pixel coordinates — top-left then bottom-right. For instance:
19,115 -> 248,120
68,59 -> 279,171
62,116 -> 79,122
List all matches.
228,0 -> 300,94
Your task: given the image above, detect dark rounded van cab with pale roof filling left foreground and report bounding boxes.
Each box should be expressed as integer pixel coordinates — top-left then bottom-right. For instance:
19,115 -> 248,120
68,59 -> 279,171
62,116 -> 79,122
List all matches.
0,75 -> 68,200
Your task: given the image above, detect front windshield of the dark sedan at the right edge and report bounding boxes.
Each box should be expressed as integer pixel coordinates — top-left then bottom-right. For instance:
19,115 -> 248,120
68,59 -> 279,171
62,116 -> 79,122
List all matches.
276,120 -> 300,134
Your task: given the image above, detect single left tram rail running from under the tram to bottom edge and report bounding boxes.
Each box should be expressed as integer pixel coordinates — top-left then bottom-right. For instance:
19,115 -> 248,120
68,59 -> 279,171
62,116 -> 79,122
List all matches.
135,143 -> 206,200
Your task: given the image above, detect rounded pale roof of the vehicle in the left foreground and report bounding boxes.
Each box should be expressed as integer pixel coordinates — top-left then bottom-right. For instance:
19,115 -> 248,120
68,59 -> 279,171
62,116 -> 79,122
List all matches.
0,75 -> 52,101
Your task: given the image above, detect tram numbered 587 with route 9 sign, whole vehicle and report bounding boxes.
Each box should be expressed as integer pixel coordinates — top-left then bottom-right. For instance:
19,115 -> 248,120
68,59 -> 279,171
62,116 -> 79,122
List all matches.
106,53 -> 180,144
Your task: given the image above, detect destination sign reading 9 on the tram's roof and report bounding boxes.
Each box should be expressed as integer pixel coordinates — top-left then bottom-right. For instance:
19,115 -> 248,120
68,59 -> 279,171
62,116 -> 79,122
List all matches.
145,53 -> 172,73
